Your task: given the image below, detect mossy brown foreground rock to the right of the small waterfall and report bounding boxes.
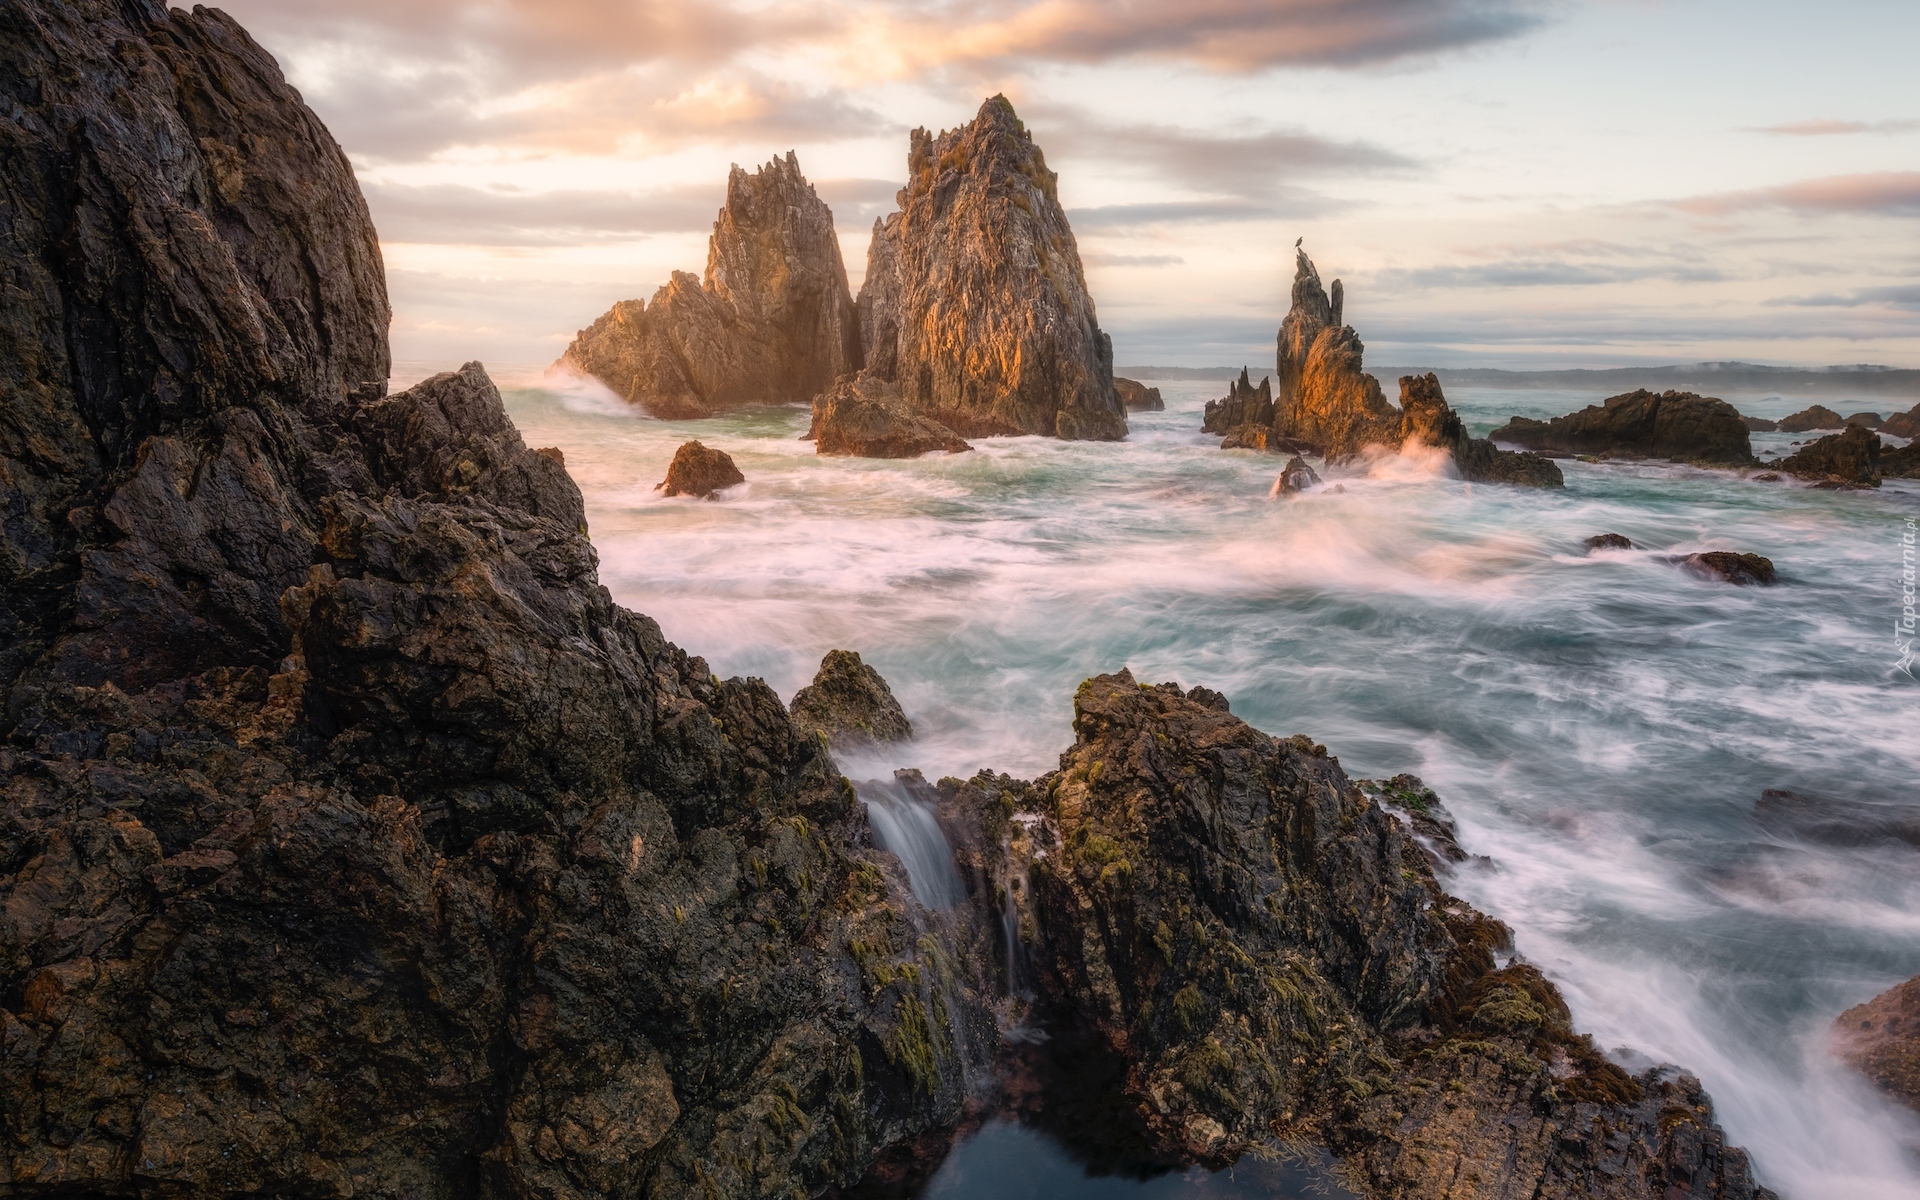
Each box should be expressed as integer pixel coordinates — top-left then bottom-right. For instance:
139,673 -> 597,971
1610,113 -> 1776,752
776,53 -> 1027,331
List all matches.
941,672 -> 1770,1200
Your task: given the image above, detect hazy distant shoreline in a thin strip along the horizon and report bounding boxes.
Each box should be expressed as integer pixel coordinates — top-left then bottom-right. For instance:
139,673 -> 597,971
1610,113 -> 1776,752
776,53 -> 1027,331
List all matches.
1114,363 -> 1920,397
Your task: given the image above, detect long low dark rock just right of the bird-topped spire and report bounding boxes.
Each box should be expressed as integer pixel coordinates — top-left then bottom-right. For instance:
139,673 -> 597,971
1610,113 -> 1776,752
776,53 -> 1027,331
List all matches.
1488,388 -> 1758,467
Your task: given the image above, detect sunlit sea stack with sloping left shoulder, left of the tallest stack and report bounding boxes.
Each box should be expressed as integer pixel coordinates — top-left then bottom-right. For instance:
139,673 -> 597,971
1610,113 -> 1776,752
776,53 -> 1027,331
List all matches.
559,150 -> 860,419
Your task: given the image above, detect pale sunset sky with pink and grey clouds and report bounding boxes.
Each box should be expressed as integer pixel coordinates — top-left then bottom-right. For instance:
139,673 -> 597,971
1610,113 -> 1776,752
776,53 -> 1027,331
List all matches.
225,0 -> 1920,376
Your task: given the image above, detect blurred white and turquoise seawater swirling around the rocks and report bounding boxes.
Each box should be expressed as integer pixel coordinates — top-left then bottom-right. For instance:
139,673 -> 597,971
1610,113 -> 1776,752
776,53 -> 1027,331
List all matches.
483,366 -> 1920,1200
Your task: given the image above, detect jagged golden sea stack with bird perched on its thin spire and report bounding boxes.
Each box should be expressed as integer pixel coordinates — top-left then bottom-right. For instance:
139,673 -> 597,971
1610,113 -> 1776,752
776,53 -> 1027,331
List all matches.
1200,252 -> 1565,488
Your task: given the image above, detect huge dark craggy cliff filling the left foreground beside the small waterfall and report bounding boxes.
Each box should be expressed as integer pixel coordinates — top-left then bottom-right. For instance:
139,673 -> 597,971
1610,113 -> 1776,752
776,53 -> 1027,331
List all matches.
0,0 -> 968,1198
